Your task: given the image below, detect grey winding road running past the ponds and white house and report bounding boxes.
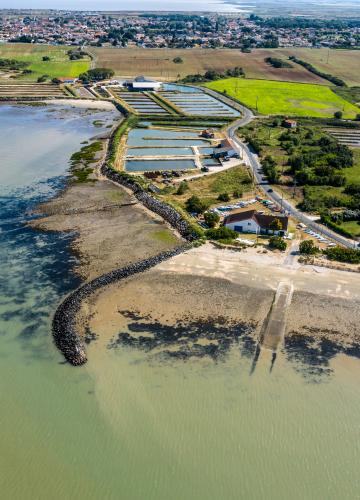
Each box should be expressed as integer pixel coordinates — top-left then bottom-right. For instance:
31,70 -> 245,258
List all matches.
205,89 -> 357,248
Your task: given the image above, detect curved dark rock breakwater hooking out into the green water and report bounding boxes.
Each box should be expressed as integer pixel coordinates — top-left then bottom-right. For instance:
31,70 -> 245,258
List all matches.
52,245 -> 189,366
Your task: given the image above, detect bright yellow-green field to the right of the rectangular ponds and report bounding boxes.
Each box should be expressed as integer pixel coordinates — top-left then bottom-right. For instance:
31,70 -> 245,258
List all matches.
206,78 -> 360,118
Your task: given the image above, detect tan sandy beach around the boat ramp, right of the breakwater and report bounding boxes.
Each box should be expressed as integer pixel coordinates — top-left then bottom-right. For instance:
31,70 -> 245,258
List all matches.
76,244 -> 360,360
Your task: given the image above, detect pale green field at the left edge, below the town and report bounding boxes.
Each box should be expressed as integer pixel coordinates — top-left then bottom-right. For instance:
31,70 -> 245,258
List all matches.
0,43 -> 90,81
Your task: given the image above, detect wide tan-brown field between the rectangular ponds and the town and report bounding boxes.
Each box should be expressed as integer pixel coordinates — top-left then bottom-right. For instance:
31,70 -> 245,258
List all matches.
91,48 -> 330,84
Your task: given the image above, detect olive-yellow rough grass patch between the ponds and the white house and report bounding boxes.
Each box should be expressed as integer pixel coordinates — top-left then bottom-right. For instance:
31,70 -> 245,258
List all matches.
159,166 -> 252,207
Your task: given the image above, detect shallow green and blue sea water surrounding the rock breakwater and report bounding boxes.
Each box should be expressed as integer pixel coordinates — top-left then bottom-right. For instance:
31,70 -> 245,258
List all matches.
0,103 -> 360,500
